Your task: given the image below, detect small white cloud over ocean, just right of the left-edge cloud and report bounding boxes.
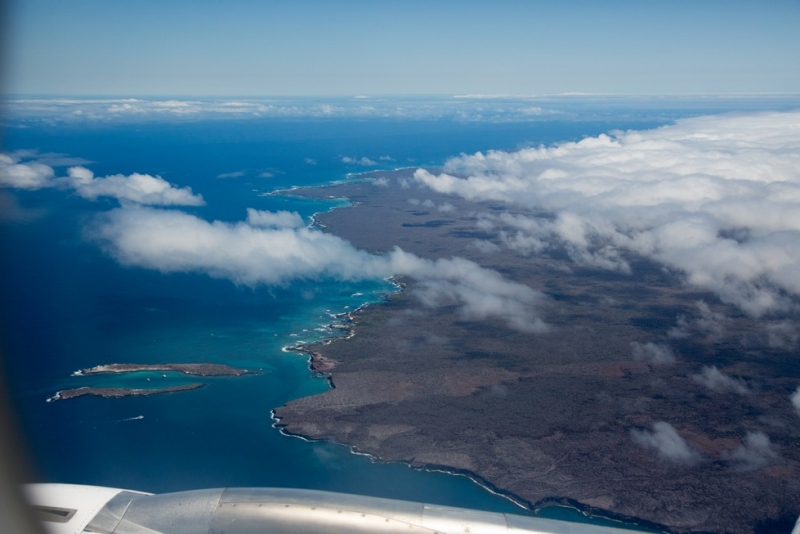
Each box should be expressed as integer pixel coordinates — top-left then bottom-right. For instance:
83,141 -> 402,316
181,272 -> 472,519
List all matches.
67,167 -> 205,206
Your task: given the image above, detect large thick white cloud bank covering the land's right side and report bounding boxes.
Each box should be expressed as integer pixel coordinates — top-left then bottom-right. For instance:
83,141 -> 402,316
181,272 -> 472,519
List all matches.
414,112 -> 800,316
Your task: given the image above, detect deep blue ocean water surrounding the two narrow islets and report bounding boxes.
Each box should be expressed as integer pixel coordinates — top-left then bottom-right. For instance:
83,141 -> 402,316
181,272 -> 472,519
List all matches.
1,111 -> 740,532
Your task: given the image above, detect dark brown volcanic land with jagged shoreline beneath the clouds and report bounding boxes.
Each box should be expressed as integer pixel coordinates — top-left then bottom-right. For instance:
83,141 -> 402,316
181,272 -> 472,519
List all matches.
276,171 -> 800,532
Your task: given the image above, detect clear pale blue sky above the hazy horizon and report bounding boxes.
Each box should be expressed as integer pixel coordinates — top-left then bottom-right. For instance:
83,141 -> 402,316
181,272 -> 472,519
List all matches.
4,0 -> 800,96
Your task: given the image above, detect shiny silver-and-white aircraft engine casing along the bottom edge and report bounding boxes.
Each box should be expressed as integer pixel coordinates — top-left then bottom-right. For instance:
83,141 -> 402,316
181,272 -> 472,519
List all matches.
23,484 -> 656,534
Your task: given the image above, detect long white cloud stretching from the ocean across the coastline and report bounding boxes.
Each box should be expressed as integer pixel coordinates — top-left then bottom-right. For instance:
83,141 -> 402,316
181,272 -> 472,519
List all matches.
89,206 -> 548,333
